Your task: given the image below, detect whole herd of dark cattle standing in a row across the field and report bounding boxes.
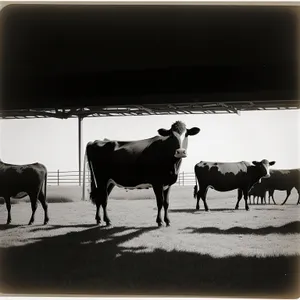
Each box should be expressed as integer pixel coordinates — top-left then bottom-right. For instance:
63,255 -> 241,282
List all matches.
0,121 -> 300,226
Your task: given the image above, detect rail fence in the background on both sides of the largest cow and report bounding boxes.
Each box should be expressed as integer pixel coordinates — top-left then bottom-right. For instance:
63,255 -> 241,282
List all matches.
47,170 -> 196,186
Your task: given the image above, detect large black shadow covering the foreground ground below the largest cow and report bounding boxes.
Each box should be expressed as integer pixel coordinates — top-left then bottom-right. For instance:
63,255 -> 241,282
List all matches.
0,226 -> 300,298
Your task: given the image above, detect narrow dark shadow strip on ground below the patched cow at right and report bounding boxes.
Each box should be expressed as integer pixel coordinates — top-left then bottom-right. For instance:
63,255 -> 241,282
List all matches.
183,221 -> 300,235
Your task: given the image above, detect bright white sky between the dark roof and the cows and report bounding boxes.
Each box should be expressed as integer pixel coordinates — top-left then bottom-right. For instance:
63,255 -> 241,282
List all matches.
0,110 -> 300,172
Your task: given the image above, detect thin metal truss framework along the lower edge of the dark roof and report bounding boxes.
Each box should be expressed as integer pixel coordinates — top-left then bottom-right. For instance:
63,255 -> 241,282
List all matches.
0,101 -> 300,119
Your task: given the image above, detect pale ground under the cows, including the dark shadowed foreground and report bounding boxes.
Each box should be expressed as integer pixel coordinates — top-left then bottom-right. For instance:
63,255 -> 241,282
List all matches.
0,187 -> 300,298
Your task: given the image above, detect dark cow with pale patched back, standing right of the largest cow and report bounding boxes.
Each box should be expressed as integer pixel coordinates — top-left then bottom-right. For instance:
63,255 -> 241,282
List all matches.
194,159 -> 275,211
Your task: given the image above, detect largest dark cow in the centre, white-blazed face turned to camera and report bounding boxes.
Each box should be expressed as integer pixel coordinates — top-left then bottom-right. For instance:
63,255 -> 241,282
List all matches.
83,121 -> 200,226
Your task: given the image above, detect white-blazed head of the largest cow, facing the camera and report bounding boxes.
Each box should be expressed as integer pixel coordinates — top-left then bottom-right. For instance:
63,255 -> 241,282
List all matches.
158,121 -> 200,158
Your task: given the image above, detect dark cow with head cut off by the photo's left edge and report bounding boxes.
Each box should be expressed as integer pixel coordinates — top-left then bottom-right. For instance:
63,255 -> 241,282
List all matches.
0,160 -> 49,225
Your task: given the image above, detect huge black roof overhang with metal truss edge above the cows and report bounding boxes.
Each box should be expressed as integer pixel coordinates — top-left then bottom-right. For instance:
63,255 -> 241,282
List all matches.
0,4 -> 300,118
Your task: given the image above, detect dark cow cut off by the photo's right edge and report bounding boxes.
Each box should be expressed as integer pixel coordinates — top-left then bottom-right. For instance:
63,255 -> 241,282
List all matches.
261,169 -> 300,205
